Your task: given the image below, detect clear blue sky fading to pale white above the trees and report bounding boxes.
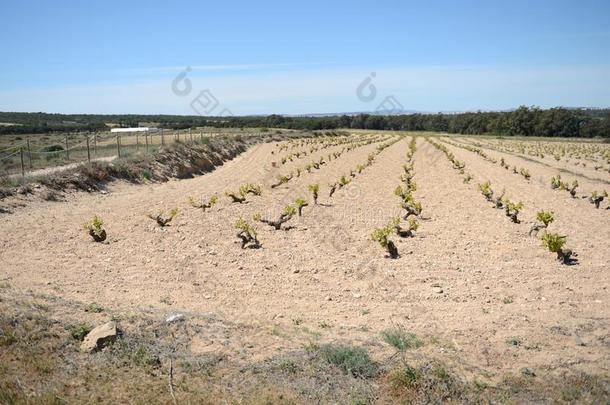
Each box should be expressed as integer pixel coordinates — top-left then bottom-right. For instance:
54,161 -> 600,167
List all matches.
0,0 -> 610,115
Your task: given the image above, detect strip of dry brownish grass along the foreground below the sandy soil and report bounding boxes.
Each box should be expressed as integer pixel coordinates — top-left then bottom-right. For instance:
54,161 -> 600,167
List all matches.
0,284 -> 610,404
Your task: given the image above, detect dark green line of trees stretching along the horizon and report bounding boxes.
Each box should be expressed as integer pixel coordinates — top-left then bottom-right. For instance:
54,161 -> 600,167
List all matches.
0,107 -> 610,138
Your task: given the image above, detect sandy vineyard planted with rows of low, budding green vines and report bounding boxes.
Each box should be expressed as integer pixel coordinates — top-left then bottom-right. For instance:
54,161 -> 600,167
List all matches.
0,130 -> 610,402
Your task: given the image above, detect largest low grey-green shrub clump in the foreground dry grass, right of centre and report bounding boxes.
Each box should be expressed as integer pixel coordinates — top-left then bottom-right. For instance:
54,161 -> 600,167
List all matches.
318,344 -> 377,378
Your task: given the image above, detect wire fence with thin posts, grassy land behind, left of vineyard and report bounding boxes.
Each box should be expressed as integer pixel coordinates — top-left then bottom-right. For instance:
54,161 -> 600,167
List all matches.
0,129 -> 268,177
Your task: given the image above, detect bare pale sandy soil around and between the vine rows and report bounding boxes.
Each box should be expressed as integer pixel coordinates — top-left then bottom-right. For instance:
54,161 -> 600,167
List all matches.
0,132 -> 610,400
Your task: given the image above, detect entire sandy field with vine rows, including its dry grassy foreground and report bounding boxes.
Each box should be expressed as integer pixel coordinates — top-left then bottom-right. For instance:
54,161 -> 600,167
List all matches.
0,131 -> 610,403
